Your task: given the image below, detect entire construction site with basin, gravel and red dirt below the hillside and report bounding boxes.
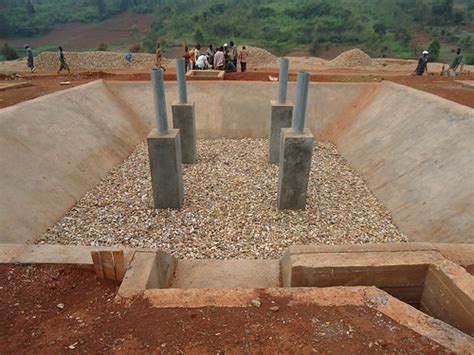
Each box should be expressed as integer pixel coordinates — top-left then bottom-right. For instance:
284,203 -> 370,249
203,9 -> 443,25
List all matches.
0,48 -> 474,354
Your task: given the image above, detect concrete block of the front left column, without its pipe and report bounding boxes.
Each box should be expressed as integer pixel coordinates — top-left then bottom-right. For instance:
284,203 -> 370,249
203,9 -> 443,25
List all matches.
147,129 -> 184,208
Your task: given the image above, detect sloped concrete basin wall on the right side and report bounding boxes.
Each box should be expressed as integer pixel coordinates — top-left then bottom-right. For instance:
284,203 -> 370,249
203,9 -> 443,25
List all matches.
319,83 -> 474,243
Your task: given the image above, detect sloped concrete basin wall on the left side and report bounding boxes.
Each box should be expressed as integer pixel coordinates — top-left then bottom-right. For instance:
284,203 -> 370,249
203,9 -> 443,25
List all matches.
0,81 -> 148,243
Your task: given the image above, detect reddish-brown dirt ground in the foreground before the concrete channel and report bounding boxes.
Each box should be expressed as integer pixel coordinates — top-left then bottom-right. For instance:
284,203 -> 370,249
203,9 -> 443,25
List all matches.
0,264 -> 444,354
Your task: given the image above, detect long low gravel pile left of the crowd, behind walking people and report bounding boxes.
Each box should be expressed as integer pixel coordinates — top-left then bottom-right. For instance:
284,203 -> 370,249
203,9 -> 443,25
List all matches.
35,52 -> 172,71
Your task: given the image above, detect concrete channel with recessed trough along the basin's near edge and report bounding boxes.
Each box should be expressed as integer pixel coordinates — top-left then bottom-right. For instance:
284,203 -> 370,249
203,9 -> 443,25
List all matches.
115,247 -> 474,336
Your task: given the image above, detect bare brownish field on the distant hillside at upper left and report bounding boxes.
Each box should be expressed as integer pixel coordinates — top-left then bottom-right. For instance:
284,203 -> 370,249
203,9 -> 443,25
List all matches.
0,13 -> 154,51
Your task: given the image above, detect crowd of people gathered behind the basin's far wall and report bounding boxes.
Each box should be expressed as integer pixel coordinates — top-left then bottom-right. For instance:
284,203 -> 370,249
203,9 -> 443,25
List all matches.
183,41 -> 250,73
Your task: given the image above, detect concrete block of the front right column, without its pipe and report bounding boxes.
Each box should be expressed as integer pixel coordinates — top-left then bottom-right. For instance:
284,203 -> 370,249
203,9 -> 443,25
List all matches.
278,128 -> 314,210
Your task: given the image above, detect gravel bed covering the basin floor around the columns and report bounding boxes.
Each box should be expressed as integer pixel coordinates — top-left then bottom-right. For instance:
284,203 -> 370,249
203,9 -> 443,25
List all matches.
38,139 -> 407,259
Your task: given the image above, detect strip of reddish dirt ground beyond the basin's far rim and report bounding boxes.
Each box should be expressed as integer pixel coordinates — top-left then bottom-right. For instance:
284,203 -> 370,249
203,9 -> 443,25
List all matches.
0,69 -> 474,108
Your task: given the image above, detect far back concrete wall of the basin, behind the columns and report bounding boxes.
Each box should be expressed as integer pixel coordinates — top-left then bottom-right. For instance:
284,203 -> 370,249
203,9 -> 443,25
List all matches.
107,81 -> 366,138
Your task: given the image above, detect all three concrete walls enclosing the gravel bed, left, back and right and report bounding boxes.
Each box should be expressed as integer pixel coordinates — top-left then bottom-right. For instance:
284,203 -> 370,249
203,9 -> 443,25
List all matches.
0,81 -> 474,243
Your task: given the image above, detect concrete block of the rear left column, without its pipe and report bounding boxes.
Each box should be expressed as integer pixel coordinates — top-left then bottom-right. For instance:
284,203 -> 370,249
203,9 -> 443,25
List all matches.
171,102 -> 197,164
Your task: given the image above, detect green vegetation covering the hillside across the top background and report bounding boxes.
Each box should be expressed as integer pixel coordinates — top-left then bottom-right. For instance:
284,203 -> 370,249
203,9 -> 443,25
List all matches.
0,0 -> 474,58
